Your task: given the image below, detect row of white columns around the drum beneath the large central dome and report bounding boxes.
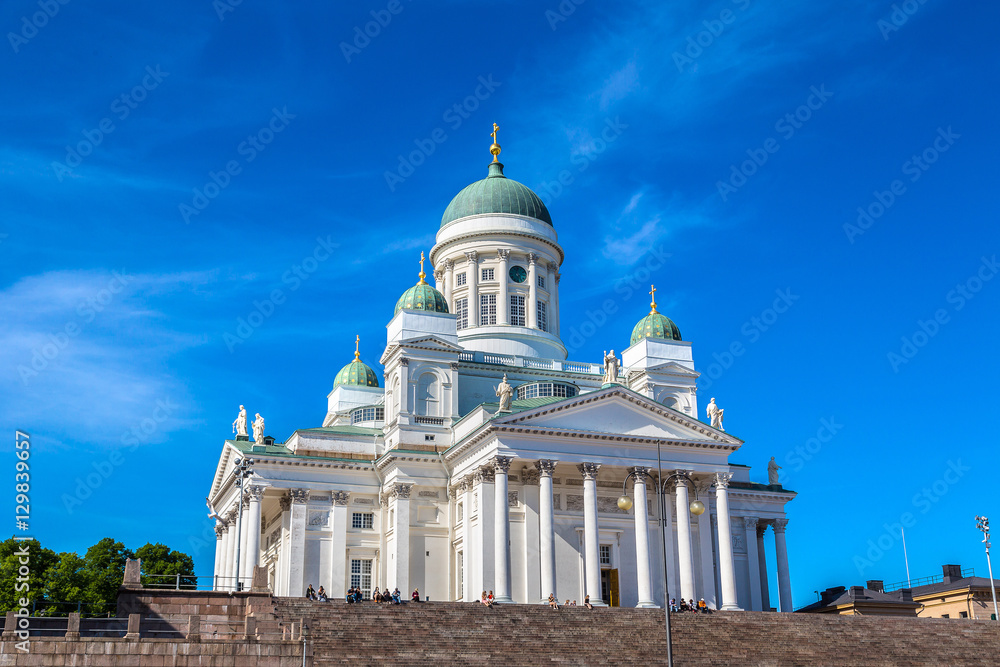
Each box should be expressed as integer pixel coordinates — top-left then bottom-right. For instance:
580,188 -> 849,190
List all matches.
434,248 -> 559,336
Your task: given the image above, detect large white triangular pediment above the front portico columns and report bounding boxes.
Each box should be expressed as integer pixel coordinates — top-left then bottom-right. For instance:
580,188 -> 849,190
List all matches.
493,386 -> 743,449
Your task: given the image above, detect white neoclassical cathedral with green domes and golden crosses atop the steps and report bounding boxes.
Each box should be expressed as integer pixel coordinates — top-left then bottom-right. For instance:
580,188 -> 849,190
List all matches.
209,133 -> 795,611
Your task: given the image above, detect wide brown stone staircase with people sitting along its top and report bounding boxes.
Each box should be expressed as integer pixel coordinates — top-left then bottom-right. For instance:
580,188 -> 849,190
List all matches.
274,598 -> 1000,667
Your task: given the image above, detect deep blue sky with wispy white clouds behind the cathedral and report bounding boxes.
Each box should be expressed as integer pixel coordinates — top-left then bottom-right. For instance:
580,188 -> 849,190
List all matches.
0,0 -> 1000,606
